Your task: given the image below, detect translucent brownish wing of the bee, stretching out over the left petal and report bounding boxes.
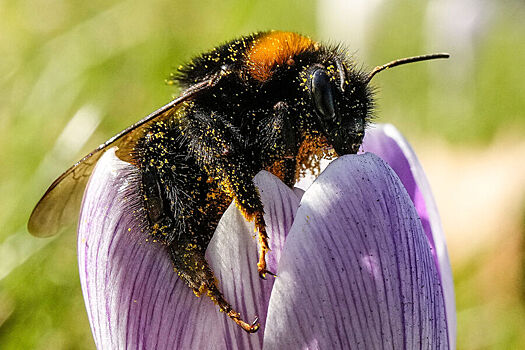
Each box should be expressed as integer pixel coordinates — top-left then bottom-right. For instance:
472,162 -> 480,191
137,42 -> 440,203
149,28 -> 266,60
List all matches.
27,78 -> 215,237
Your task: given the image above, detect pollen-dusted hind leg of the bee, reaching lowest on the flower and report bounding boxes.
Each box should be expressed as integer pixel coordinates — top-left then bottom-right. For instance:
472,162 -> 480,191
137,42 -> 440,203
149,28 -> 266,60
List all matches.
168,241 -> 259,333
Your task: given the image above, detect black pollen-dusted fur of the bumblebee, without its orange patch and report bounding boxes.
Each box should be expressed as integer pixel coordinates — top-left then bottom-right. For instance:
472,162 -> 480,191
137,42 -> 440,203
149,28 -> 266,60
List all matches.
134,33 -> 373,330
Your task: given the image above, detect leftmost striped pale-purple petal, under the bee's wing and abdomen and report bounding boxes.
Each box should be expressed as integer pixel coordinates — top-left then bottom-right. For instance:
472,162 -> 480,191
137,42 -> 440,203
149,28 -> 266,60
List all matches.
78,150 -> 221,349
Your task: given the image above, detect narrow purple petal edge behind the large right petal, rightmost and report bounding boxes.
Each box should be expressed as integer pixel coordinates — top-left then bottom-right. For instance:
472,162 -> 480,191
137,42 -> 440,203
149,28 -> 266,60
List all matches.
362,124 -> 456,348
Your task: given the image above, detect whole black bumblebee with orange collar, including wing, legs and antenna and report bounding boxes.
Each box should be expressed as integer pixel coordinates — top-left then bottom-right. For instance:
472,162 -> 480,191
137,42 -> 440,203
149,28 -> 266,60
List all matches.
28,31 -> 448,332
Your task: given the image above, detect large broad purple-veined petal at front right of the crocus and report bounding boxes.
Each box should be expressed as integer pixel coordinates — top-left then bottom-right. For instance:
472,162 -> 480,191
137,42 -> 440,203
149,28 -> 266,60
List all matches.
264,154 -> 449,349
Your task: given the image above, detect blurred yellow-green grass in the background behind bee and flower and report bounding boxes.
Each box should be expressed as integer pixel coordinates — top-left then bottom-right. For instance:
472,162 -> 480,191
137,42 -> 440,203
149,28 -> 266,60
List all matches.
0,0 -> 525,349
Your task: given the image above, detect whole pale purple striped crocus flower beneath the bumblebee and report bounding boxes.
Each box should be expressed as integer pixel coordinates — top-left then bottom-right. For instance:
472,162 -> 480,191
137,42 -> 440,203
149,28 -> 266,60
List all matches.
78,126 -> 455,349
